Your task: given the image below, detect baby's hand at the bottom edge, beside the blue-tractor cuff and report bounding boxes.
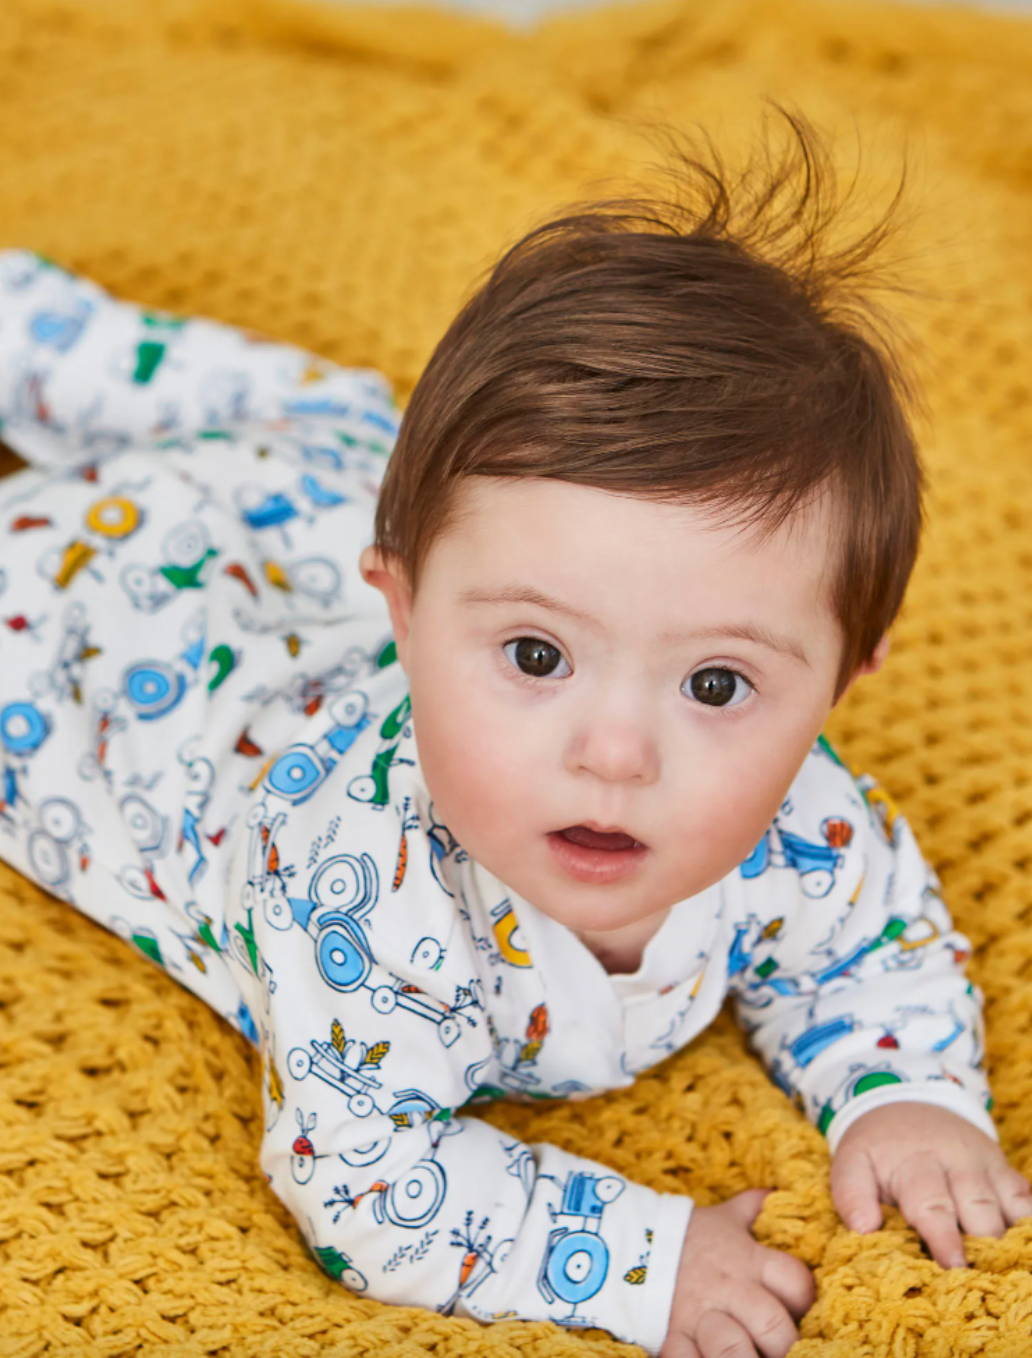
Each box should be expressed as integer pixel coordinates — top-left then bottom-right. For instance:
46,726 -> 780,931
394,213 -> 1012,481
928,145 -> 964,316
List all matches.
660,1189 -> 814,1358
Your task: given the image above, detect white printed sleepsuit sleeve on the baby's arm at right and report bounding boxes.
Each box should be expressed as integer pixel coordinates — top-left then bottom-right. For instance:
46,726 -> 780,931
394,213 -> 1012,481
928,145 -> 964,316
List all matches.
729,739 -> 998,1153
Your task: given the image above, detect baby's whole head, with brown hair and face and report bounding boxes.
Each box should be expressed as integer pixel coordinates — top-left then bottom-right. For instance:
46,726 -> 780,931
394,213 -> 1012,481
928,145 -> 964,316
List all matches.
363,122 -> 921,961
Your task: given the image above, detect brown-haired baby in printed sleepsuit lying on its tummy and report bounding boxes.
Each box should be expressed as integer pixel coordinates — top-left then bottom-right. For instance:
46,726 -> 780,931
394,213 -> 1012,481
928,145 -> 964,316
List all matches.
0,127 -> 1032,1358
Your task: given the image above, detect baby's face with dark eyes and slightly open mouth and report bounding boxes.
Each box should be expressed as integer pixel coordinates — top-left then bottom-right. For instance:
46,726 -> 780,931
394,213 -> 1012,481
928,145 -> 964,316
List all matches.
363,477 -> 874,936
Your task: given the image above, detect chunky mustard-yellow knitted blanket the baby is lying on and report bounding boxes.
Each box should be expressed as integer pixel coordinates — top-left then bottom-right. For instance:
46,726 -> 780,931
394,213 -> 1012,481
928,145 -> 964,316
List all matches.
0,0 -> 1032,1358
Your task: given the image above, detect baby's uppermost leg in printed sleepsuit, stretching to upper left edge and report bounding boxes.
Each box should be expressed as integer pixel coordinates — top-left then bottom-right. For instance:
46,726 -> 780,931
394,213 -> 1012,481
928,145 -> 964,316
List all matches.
0,250 -> 398,467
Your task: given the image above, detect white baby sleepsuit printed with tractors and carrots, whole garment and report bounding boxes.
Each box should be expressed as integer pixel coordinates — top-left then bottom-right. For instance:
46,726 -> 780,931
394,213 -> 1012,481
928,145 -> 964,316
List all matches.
0,251 -> 995,1353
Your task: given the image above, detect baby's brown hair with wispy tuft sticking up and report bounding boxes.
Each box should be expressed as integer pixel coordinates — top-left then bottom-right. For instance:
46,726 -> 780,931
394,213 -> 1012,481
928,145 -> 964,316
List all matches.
375,110 -> 922,691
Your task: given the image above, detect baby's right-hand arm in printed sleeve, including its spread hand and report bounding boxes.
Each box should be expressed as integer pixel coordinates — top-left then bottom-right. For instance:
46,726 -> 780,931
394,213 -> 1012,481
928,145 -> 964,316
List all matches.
732,747 -> 1032,1266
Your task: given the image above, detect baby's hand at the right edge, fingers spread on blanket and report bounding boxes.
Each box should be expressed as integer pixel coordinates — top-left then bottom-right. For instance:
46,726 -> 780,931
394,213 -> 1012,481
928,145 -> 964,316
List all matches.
831,1101 -> 1032,1268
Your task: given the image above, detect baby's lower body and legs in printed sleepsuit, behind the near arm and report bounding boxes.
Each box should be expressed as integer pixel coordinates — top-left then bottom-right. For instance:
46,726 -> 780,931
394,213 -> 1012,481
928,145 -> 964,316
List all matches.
0,253 -> 397,1035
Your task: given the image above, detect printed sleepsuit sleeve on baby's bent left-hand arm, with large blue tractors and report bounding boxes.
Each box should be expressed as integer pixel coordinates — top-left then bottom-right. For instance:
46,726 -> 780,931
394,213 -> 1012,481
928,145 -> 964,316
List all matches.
228,699 -> 691,1353
